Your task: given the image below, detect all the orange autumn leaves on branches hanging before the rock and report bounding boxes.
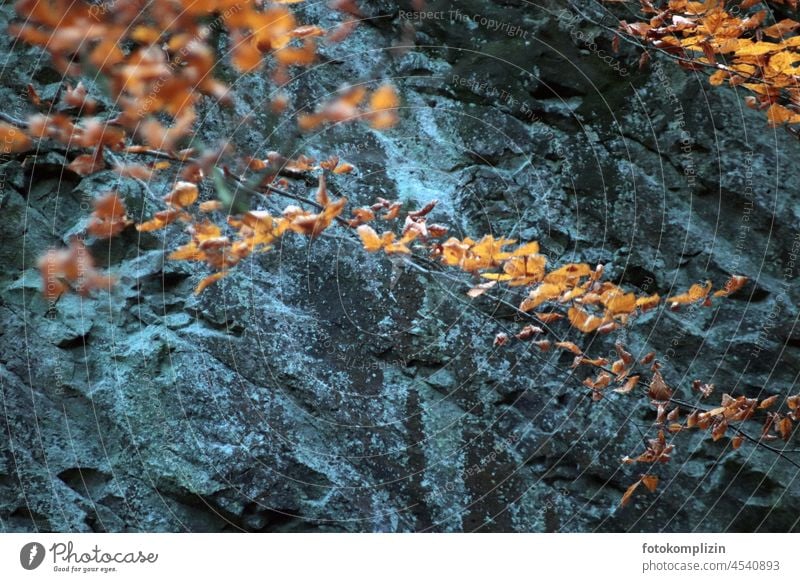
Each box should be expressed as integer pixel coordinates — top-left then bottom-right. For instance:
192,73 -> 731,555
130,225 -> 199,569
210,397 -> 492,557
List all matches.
0,0 -> 800,504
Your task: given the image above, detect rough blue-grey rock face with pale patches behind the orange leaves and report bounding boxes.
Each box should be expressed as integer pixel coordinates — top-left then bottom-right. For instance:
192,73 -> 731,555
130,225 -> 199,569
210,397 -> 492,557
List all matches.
0,0 -> 800,532
